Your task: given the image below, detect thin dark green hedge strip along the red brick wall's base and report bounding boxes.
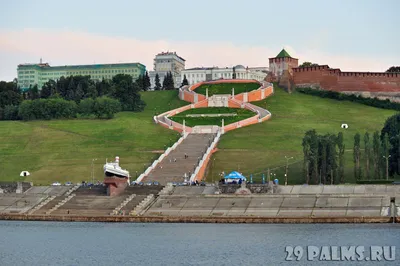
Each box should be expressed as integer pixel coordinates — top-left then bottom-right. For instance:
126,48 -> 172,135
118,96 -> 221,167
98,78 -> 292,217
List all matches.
296,88 -> 400,111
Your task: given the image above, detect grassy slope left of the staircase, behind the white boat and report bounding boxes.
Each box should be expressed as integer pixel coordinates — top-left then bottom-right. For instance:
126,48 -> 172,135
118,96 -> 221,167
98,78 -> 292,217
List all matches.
0,91 -> 187,184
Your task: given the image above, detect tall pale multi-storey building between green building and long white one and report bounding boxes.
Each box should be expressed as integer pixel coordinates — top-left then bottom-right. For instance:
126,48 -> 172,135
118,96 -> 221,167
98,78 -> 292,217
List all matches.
149,52 -> 186,88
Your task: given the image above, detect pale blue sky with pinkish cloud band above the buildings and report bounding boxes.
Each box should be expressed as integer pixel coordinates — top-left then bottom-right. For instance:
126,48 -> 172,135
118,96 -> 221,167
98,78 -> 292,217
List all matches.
0,0 -> 400,80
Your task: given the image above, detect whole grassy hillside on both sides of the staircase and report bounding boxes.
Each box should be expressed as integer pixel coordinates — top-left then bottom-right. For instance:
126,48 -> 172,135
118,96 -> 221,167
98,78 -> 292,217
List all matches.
0,85 -> 395,184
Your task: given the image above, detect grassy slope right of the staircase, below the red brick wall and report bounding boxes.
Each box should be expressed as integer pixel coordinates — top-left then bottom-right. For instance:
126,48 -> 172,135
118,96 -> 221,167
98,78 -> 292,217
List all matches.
207,86 -> 395,184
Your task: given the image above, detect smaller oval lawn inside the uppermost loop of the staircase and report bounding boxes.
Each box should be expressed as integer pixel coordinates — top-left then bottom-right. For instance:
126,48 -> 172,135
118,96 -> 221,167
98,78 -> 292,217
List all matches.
195,82 -> 260,96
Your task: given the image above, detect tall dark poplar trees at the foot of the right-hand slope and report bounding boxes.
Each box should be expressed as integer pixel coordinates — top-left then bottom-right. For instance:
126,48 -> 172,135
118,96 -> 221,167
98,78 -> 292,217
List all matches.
302,114 -> 400,184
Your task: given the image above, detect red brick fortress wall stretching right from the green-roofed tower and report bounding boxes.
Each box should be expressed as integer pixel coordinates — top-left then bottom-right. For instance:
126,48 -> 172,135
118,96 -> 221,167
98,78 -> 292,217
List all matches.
293,65 -> 400,93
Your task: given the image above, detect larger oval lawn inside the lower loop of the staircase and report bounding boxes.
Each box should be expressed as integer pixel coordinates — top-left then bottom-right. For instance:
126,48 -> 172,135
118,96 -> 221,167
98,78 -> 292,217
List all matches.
170,107 -> 255,127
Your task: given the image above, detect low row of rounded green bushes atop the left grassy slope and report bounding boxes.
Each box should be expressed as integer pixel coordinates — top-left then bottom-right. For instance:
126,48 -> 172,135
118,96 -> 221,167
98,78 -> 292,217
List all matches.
0,97 -> 121,121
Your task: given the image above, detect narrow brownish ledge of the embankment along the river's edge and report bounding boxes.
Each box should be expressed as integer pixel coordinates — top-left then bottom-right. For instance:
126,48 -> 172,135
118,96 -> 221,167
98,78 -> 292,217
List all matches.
0,214 -> 400,224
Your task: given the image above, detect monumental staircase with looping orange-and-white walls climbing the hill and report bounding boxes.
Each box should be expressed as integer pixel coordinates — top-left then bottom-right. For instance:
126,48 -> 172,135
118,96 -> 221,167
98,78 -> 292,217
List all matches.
136,80 -> 273,185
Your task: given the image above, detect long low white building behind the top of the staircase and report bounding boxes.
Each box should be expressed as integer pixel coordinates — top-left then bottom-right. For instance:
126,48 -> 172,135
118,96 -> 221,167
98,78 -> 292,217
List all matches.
181,65 -> 268,85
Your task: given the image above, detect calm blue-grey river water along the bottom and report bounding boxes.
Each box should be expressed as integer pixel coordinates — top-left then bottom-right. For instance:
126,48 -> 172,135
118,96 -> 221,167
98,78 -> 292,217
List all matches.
0,221 -> 400,266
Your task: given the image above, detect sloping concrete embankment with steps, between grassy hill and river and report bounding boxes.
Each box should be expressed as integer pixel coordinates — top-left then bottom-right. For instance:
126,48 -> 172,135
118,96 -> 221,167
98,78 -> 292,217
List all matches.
0,185 -> 400,223
